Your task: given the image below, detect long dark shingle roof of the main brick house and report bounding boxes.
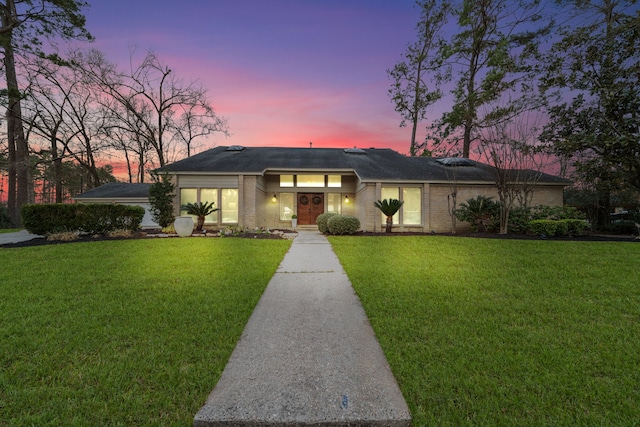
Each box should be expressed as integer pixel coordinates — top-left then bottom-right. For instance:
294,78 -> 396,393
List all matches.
158,146 -> 571,185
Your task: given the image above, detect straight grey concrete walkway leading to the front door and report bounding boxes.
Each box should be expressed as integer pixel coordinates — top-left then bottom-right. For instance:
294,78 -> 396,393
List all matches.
193,231 -> 411,427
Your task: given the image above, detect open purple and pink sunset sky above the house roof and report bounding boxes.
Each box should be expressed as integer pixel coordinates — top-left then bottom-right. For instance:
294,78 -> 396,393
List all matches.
79,0 -> 418,153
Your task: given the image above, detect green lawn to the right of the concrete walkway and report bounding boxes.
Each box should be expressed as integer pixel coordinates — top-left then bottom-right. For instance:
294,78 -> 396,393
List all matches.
330,236 -> 640,426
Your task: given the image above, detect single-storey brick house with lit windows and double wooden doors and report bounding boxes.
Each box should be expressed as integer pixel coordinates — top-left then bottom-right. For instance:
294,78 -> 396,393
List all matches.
157,145 -> 571,232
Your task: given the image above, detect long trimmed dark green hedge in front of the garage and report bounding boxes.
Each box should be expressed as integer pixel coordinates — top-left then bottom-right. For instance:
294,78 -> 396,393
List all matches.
20,203 -> 144,235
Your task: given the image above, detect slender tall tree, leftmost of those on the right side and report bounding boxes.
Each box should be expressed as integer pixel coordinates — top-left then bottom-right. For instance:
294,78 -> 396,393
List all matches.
387,0 -> 449,156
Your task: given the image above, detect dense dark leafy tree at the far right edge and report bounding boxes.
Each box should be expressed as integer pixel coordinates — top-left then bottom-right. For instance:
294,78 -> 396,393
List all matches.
541,0 -> 640,226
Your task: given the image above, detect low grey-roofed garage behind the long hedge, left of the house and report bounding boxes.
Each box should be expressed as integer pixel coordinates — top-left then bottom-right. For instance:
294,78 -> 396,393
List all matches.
73,182 -> 159,228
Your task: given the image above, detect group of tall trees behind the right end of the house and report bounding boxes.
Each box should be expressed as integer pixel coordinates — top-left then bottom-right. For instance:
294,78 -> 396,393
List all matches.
387,0 -> 640,231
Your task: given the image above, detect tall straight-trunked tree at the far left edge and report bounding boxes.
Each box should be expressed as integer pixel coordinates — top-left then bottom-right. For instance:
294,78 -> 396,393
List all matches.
0,0 -> 92,224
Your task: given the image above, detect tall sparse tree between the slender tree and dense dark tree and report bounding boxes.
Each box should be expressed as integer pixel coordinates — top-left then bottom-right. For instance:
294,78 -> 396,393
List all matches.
430,0 -> 552,158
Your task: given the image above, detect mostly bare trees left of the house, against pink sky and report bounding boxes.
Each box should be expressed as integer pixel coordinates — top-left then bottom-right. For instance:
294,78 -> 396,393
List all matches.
0,0 -> 227,224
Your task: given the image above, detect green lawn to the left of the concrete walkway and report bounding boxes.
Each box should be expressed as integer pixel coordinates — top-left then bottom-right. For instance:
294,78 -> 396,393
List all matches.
0,238 -> 290,426
